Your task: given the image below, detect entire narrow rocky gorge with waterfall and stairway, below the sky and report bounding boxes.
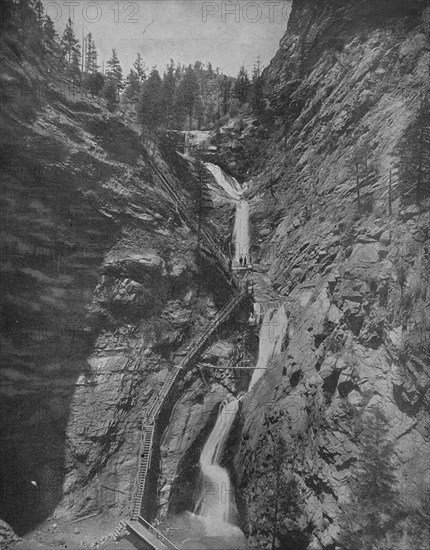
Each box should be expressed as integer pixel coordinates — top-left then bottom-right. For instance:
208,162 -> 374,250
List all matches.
0,0 -> 430,550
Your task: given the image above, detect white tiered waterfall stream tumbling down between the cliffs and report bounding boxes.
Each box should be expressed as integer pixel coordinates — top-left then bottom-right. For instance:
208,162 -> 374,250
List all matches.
176,164 -> 288,550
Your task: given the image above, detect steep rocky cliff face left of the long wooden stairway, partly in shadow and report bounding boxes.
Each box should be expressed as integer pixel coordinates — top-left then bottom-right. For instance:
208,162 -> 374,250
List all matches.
1,28 -> 239,544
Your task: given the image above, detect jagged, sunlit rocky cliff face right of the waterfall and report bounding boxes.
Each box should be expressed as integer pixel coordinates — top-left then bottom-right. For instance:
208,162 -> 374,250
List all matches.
236,0 -> 430,549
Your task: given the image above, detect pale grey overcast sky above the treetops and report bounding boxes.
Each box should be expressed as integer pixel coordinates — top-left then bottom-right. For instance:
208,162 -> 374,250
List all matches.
43,0 -> 291,76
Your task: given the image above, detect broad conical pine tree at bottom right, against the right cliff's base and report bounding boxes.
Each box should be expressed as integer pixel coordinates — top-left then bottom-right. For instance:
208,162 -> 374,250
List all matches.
339,408 -> 405,550
